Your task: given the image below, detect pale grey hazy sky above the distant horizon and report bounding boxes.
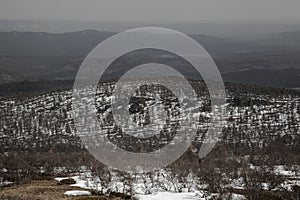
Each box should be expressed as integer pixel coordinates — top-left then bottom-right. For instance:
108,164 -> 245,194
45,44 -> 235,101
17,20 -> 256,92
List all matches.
0,0 -> 300,22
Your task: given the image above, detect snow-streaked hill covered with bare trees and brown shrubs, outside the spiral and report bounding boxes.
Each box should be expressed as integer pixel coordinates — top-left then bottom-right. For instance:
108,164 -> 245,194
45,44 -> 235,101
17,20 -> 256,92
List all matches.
0,81 -> 300,199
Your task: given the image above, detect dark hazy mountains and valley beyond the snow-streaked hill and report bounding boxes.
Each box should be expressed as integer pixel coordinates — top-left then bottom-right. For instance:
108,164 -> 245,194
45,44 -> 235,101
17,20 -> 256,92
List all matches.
0,30 -> 300,88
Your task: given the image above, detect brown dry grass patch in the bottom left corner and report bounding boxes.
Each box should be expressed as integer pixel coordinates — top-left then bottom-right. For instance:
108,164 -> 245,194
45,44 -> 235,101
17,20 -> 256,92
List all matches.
0,180 -> 109,200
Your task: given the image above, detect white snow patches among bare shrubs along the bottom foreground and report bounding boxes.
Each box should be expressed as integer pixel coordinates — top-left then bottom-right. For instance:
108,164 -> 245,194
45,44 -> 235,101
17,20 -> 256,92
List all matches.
55,164 -> 300,200
